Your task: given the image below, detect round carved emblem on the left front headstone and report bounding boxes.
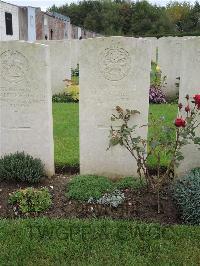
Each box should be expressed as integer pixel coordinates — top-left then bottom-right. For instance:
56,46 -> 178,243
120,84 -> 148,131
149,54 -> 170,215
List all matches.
0,50 -> 29,83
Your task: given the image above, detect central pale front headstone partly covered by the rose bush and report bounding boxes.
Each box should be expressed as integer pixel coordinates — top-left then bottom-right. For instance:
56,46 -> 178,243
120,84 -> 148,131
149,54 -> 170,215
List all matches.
80,37 -> 151,177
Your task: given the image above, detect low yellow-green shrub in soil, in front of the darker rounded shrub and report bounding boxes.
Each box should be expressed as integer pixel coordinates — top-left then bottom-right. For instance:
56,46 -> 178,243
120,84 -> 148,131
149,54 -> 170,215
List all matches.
8,187 -> 52,214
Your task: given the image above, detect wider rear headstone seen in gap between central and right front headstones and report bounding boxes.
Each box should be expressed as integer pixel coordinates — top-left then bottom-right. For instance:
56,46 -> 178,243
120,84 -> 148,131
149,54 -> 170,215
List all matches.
158,37 -> 184,99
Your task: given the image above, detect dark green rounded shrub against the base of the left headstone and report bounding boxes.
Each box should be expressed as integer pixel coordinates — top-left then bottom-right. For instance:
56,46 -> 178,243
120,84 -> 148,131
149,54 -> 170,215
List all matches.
0,152 -> 45,183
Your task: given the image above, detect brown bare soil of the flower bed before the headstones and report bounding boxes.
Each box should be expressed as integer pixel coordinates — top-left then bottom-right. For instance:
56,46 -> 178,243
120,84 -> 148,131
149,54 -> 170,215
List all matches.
0,175 -> 181,224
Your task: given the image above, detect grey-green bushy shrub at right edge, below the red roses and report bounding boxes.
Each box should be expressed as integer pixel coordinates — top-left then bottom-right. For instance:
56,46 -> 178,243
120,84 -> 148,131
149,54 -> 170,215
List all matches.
172,168 -> 200,225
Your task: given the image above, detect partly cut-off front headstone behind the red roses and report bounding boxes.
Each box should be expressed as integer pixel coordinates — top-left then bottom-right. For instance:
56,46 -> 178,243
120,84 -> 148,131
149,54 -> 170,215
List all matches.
176,38 -> 200,176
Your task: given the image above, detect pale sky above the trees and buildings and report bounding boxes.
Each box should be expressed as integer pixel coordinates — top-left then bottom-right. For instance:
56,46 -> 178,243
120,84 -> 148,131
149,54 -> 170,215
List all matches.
3,0 -> 198,11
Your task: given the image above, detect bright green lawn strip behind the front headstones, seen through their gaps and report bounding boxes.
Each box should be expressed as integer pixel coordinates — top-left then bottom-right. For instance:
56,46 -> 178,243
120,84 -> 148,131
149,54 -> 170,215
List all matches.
53,103 -> 177,172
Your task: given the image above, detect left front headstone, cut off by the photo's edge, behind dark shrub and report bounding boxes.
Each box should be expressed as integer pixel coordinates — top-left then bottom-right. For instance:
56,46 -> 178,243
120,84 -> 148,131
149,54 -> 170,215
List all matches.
0,41 -> 54,176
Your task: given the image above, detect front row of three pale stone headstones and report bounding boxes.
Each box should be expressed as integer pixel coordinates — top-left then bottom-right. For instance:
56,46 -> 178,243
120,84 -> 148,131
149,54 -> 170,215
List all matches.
0,37 -> 200,177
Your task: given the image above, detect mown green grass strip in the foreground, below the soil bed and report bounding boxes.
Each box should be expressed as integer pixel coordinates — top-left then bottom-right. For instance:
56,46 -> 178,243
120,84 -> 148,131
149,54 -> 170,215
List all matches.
0,218 -> 200,266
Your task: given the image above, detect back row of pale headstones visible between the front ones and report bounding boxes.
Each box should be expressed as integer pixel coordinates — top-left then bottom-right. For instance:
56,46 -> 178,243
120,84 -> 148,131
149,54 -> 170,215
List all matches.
36,36 -> 198,99
